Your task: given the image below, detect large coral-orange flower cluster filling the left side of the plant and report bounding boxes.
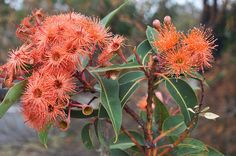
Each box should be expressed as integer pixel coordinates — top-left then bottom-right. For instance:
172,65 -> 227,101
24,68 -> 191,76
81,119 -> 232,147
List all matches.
1,10 -> 124,131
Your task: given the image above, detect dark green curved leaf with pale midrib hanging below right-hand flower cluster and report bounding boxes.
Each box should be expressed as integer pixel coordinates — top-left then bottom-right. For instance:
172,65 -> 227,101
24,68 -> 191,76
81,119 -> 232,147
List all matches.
165,77 -> 198,125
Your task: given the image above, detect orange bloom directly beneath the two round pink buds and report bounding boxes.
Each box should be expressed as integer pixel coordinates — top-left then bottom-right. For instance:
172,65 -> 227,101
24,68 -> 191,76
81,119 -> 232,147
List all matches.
153,23 -> 181,52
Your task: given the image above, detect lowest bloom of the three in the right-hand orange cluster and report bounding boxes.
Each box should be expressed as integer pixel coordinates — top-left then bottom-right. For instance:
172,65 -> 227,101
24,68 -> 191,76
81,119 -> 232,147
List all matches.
160,47 -> 192,77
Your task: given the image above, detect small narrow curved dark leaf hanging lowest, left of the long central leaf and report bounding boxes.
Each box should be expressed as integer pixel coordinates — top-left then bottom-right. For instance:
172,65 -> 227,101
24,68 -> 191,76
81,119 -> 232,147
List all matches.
81,123 -> 93,149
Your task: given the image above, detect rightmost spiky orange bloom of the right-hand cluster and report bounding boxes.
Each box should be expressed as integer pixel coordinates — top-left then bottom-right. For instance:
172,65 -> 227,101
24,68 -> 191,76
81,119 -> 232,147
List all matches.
183,27 -> 216,70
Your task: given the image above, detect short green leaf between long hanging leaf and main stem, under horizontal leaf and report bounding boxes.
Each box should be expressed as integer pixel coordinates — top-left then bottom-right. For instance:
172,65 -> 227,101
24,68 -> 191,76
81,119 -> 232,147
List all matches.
118,71 -> 145,85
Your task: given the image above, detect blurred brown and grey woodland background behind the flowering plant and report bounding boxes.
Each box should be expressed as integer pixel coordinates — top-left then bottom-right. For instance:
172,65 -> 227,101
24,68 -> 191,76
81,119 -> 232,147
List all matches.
0,0 -> 236,156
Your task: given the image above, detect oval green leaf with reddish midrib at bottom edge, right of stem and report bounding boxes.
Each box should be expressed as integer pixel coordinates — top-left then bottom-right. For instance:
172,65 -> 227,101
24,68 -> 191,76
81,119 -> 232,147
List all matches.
174,138 -> 207,156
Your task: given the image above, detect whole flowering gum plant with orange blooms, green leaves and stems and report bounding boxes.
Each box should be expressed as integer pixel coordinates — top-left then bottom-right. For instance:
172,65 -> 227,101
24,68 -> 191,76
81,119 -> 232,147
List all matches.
0,2 -> 225,156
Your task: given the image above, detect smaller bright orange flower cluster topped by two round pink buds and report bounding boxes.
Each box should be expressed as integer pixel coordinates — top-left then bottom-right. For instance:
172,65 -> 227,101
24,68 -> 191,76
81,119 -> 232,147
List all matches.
153,16 -> 216,77
